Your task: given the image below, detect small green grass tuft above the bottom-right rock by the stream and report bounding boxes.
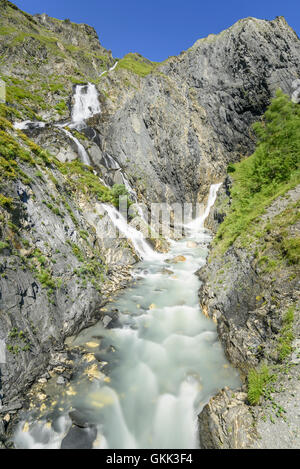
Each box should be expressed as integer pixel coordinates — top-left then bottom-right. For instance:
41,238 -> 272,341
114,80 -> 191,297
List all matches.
248,365 -> 276,405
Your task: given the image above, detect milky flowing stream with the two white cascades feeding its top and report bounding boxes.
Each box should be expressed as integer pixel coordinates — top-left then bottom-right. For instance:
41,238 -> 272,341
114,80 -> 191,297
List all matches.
15,185 -> 239,449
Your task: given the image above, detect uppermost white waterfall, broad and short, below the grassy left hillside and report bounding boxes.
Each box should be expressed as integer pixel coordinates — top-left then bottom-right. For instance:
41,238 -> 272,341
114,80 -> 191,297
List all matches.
71,83 -> 101,125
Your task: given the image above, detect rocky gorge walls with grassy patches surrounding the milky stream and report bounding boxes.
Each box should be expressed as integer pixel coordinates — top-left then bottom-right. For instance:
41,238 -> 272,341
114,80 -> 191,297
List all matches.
0,0 -> 300,448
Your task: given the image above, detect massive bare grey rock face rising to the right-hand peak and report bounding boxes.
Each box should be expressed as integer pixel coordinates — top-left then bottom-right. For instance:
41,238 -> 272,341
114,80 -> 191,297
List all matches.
101,17 -> 300,201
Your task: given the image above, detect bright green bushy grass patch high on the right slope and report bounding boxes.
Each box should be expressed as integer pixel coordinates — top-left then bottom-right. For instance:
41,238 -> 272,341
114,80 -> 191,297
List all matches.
215,91 -> 300,252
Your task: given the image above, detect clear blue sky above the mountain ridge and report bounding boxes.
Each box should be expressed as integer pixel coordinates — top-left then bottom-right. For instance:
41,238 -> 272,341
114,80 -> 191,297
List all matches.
13,0 -> 300,61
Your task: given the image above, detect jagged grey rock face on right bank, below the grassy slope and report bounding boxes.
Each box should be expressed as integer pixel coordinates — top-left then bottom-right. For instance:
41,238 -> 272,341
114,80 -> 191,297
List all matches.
199,185 -> 300,372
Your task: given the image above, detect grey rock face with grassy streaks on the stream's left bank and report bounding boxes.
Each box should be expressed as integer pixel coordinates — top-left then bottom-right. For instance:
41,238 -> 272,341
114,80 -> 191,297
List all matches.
0,154 -> 136,411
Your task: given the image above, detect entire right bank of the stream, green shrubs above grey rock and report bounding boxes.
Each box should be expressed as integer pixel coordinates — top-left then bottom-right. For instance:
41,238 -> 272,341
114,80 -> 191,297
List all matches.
199,93 -> 300,449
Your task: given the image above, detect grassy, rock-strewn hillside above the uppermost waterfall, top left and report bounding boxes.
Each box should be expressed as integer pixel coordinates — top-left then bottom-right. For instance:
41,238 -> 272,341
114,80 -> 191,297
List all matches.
0,2 -> 112,119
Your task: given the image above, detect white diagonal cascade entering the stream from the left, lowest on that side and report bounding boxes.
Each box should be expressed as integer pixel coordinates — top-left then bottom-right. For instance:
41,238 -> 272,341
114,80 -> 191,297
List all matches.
104,205 -> 162,261
